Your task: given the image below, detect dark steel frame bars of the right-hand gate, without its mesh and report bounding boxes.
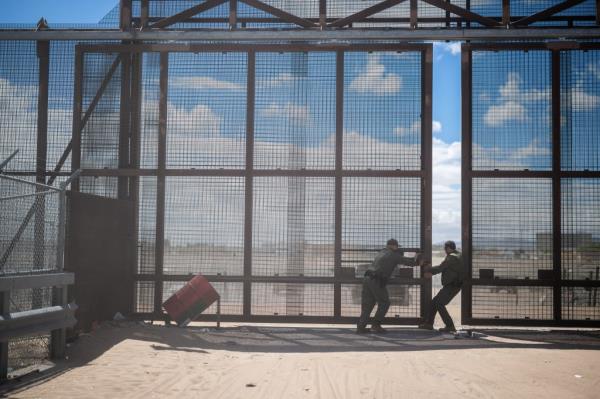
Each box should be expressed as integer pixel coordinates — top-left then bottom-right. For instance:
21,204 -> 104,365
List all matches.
461,42 -> 600,327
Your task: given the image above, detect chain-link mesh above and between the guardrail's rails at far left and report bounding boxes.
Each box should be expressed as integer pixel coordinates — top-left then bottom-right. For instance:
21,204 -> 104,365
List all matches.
0,175 -> 64,373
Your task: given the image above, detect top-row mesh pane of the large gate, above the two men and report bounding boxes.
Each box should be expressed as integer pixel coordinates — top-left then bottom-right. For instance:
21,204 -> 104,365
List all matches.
343,52 -> 422,170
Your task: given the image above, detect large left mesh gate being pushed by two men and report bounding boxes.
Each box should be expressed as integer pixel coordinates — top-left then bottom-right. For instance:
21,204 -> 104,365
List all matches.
72,43 -> 432,324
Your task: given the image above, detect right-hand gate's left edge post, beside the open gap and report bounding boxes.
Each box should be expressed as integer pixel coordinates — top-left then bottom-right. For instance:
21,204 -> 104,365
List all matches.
461,44 -> 473,324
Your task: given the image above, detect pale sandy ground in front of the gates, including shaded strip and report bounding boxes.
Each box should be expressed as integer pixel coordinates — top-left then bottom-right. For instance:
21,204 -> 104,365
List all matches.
4,322 -> 600,399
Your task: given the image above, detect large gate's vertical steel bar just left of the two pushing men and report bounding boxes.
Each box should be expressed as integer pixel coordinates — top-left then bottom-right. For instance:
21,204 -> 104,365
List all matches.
333,51 -> 345,318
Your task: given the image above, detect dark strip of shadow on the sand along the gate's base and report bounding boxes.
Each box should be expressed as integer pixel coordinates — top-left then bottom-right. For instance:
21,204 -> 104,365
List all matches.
0,322 -> 600,394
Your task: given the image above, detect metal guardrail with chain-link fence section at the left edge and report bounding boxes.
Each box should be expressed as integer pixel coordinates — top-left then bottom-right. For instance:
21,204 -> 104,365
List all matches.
0,151 -> 79,381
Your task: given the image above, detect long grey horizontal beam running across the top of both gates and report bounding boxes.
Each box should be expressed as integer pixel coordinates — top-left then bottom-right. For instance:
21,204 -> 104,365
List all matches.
0,27 -> 600,44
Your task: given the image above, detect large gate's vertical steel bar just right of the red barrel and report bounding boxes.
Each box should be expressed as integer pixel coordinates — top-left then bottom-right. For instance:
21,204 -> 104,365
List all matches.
243,51 -> 256,319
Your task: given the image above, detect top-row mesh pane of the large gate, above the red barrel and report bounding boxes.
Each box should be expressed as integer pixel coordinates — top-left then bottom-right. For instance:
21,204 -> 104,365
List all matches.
167,53 -> 247,169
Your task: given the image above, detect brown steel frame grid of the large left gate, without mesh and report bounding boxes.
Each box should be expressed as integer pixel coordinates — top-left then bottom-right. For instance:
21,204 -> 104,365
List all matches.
77,44 -> 433,324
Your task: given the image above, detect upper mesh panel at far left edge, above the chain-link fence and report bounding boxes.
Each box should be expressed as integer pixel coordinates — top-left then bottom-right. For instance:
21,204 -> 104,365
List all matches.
0,41 -> 39,171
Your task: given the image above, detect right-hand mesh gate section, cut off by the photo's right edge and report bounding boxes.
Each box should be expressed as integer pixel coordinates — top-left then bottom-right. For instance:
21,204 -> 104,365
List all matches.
462,41 -> 600,326
